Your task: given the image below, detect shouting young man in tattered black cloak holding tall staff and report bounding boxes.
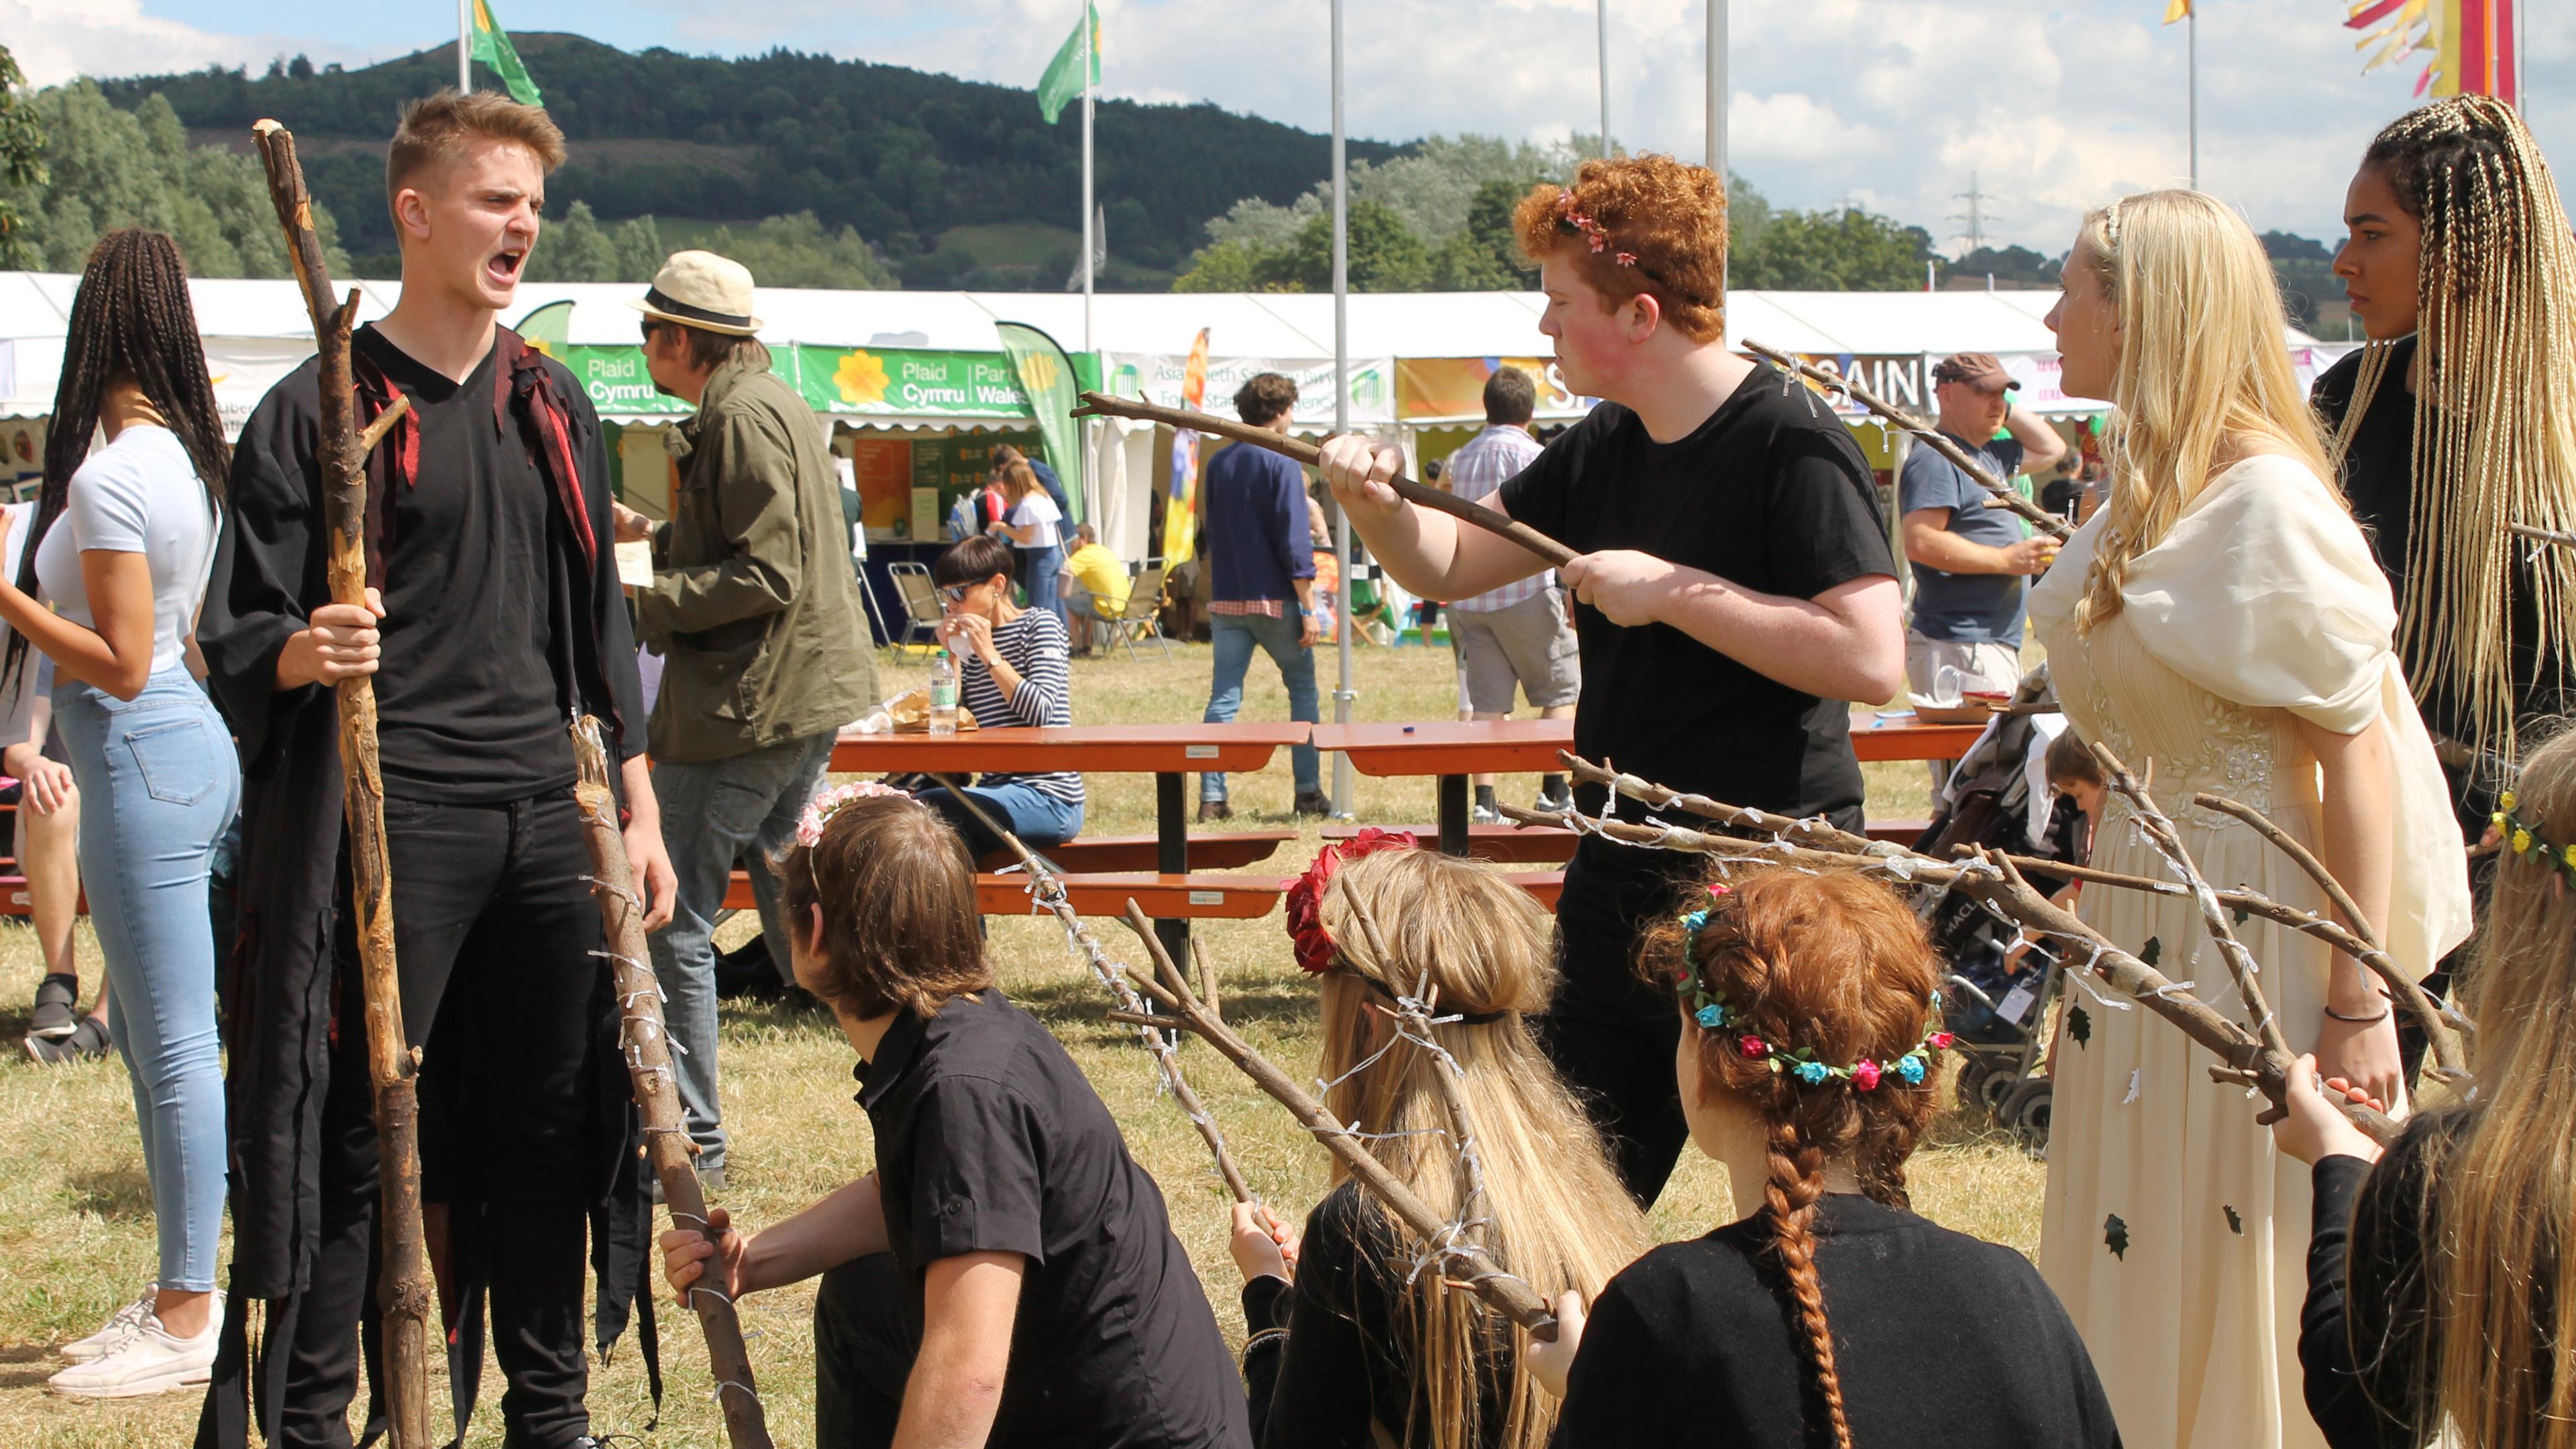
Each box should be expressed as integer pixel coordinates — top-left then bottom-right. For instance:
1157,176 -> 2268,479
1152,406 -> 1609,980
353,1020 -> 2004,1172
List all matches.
199,93 -> 672,1449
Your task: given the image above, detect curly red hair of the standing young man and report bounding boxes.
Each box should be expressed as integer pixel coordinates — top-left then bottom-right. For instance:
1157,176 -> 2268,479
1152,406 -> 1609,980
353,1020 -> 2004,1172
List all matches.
1512,152 -> 1726,343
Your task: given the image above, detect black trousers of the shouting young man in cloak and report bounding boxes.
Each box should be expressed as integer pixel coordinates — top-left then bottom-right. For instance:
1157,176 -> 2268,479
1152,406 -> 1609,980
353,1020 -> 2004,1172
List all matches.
281,786 -> 605,1449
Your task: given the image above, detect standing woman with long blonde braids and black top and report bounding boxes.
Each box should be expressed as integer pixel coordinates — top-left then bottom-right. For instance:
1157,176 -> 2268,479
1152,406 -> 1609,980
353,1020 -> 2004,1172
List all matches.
2316,95 -> 2576,789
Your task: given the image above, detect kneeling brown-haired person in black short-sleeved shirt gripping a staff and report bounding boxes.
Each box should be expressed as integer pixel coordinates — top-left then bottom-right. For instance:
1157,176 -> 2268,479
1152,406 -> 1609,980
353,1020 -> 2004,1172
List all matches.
662,782 -> 1249,1449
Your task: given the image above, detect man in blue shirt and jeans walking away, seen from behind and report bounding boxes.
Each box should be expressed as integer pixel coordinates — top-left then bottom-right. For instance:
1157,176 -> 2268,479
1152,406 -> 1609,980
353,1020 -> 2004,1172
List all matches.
1198,371 -> 1332,820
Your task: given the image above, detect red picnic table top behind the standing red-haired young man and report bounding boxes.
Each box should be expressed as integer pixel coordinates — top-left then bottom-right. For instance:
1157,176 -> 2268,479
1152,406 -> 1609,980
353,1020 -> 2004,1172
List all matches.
1313,712 -> 1984,856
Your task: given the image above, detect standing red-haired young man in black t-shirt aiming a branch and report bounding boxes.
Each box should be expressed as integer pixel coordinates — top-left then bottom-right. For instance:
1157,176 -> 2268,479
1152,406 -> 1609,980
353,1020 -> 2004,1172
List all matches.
1322,155 -> 1904,1201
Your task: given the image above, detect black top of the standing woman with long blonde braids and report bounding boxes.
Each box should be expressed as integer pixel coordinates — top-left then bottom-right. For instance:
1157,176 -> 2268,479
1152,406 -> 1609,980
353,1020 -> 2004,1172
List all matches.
2310,337 -> 2576,768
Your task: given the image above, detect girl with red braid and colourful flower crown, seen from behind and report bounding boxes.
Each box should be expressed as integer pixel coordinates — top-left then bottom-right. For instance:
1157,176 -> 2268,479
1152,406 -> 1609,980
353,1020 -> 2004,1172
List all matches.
1530,869 -> 2120,1449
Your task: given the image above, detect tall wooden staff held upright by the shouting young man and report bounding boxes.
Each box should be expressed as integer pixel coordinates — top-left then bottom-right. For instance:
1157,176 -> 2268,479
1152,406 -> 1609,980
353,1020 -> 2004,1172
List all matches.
250,121 -> 430,1449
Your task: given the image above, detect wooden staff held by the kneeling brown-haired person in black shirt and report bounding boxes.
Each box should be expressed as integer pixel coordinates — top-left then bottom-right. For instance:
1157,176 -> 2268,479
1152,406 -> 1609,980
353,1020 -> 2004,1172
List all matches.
572,714 -> 770,1449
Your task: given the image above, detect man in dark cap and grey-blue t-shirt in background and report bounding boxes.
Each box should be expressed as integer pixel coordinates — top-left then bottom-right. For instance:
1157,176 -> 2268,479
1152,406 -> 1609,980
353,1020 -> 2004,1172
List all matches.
1896,354 -> 2066,732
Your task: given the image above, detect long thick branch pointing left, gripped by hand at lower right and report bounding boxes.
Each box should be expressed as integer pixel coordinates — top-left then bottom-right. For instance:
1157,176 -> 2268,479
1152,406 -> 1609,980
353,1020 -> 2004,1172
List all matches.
1505,763 -> 2398,1144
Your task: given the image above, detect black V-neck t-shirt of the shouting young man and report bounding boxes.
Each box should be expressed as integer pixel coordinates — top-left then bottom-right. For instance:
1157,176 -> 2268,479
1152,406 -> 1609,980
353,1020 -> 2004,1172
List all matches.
356,325 -> 574,804
